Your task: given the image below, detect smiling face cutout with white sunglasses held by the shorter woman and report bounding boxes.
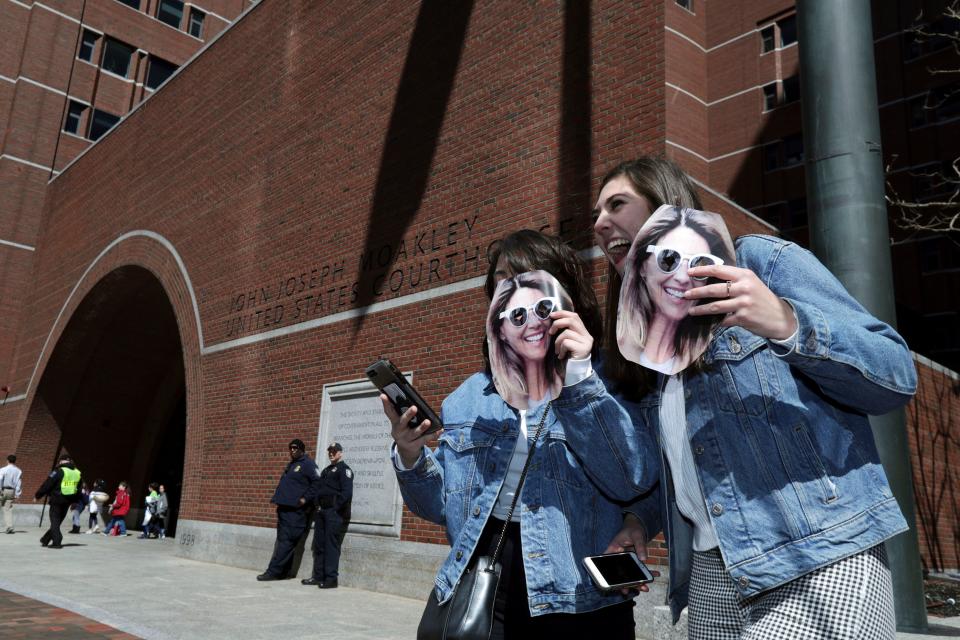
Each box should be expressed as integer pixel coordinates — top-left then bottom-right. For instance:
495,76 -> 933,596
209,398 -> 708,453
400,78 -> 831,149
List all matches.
487,271 -> 573,409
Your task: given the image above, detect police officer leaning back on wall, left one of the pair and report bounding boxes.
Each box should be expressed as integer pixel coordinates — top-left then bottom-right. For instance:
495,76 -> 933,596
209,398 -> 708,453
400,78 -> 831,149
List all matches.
257,438 -> 320,582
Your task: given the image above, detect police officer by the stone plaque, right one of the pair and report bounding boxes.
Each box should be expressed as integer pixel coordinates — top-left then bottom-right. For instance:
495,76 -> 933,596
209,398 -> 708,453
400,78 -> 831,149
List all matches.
300,442 -> 353,589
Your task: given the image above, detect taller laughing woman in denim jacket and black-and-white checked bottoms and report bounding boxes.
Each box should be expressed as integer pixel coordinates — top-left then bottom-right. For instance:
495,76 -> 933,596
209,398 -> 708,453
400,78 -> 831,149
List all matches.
594,158 -> 916,640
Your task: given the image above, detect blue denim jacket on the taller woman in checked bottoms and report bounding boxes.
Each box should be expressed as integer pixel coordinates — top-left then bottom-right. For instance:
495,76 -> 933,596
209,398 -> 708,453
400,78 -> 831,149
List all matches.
624,236 -> 917,619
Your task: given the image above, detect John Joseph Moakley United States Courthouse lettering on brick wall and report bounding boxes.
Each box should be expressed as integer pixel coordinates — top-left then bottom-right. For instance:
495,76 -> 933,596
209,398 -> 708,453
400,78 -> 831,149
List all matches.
225,214 -> 487,338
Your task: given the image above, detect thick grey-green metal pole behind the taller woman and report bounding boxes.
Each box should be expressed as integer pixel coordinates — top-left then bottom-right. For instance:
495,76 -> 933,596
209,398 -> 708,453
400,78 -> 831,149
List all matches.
797,0 -> 927,631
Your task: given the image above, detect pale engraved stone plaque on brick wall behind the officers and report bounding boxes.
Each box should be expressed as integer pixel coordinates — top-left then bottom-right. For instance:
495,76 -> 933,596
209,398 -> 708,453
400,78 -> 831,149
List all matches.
324,390 -> 397,526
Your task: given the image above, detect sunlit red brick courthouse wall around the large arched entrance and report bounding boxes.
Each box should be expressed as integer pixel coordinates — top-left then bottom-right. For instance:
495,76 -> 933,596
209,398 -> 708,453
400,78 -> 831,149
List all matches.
1,2 -> 663,542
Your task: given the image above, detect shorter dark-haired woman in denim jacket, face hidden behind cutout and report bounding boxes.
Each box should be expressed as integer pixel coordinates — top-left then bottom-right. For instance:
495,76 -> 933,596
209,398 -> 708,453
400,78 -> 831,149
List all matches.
381,231 -> 658,639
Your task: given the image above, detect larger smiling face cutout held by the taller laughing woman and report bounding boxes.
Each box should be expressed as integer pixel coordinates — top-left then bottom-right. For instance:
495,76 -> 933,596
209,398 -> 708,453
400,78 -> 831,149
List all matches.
617,205 -> 736,374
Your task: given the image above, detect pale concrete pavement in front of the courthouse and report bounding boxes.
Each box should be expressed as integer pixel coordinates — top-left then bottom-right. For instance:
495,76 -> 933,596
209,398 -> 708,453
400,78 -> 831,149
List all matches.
0,525 -> 960,640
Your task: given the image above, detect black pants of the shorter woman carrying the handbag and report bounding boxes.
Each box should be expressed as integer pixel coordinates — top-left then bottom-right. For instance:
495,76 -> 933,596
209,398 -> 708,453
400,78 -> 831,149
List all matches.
477,518 -> 635,640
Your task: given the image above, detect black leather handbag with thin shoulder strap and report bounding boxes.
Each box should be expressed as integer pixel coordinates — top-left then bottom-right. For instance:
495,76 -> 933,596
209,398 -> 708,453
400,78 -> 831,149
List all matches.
417,402 -> 550,640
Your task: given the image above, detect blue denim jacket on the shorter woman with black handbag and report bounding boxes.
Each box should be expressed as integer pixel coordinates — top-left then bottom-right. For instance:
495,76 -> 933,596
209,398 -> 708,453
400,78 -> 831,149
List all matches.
397,373 -> 659,616
